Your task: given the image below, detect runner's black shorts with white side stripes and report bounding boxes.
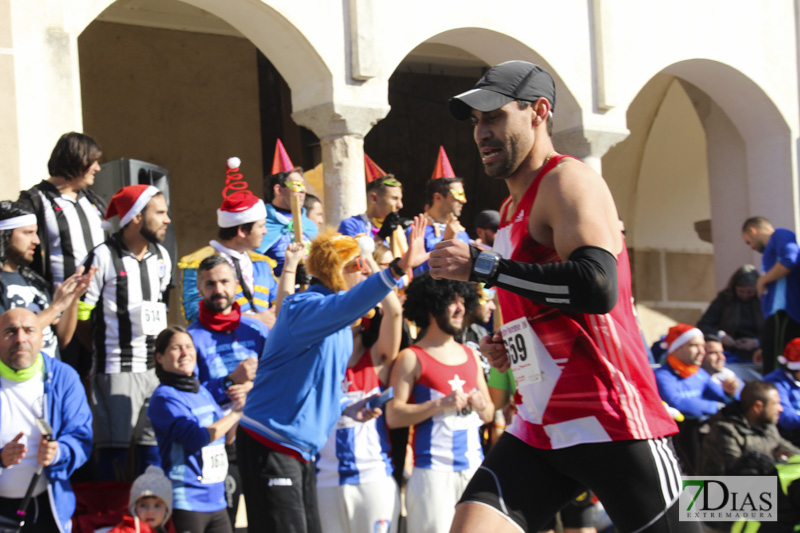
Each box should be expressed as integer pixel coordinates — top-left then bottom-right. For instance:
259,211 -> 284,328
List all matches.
461,433 -> 701,533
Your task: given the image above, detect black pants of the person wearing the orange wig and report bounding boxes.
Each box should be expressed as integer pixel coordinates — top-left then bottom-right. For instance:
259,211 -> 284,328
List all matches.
236,427 -> 322,533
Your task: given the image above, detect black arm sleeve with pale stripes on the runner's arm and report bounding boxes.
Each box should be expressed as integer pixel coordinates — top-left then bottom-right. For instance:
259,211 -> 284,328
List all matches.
488,246 -> 619,315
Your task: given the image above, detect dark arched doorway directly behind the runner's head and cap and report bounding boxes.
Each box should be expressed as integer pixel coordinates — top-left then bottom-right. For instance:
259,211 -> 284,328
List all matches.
364,28 -> 581,235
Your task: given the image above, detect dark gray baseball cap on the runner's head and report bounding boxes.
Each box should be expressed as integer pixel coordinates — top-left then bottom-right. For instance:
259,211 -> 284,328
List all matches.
450,61 -> 556,120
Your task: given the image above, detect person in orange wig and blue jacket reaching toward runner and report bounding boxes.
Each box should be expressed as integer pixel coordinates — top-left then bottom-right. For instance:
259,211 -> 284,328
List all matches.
236,216 -> 426,533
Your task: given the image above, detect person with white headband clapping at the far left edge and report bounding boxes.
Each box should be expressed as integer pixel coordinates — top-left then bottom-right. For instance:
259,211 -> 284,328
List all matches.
0,200 -> 94,357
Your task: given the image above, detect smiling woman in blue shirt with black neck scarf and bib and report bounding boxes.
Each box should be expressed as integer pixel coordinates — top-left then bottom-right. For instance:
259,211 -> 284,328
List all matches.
147,326 -> 244,533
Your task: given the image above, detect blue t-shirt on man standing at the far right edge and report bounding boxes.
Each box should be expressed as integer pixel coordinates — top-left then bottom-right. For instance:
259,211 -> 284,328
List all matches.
761,228 -> 800,322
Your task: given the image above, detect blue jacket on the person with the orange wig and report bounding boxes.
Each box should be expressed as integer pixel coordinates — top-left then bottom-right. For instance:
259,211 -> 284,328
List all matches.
239,269 -> 397,461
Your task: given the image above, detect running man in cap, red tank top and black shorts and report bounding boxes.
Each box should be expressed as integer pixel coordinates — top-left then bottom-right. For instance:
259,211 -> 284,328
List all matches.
430,61 -> 700,533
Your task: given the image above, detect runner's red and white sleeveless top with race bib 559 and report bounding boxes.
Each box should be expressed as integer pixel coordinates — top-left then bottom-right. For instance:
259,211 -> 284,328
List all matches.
494,156 -> 677,449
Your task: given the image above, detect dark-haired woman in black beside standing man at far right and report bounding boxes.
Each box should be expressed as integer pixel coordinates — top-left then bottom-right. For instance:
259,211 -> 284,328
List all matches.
697,265 -> 764,362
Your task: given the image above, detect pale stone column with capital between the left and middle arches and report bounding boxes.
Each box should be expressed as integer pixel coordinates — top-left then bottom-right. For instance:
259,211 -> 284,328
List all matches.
292,102 -> 389,227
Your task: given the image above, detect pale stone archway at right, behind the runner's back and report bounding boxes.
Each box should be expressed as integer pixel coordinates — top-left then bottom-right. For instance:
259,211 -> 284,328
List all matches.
603,59 -> 797,328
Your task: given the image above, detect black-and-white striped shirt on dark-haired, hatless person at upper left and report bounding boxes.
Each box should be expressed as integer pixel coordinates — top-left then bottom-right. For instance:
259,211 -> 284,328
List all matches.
37,182 -> 105,287
